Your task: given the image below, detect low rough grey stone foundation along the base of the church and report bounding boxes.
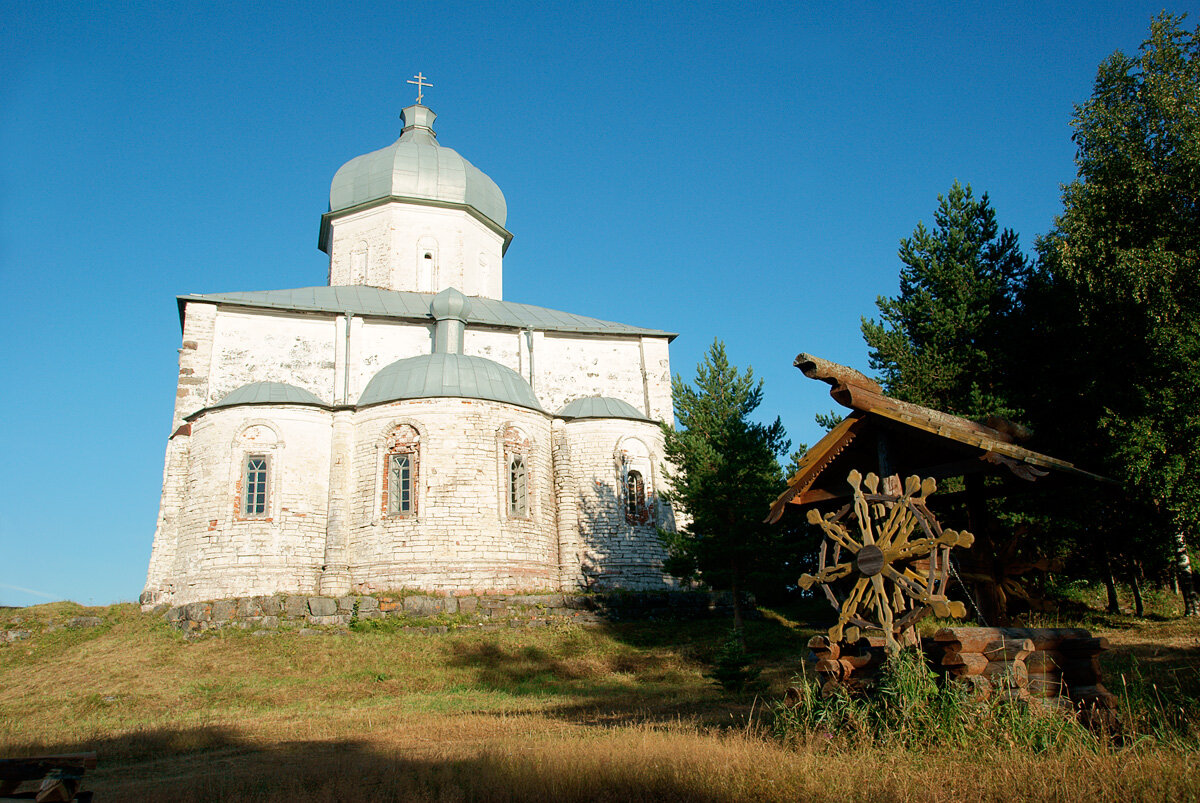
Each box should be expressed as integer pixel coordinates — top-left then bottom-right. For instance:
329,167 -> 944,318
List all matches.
157,592 -> 733,634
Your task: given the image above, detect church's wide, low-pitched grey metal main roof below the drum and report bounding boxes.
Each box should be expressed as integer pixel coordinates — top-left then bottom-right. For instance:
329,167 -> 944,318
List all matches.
178,284 -> 676,340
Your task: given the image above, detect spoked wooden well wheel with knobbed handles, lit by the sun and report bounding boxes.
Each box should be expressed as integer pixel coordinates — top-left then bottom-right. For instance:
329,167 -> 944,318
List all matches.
799,471 -> 974,653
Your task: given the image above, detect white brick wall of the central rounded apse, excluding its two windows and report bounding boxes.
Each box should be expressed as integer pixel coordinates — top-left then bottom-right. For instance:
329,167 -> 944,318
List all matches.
350,398 -> 558,593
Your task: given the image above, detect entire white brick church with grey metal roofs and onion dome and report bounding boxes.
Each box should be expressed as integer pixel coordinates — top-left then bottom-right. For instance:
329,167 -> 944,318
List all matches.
142,98 -> 674,604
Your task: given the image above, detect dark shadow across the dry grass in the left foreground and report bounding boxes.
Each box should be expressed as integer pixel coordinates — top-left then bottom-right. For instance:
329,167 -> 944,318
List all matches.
14,727 -> 737,803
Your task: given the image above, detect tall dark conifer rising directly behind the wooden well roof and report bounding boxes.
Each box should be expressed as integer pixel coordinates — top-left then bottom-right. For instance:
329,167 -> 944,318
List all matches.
863,181 -> 1028,418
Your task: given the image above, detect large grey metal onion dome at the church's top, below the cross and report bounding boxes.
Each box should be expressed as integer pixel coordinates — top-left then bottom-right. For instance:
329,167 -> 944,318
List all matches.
329,106 -> 508,229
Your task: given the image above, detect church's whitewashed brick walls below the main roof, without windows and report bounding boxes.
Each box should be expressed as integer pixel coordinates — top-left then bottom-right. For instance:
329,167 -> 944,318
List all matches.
146,301 -> 671,603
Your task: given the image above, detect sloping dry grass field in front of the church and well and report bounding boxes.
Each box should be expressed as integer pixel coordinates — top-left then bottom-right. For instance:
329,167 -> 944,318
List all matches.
0,603 -> 1200,801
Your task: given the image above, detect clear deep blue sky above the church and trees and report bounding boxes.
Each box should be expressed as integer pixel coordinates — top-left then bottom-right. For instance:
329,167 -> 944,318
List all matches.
0,0 -> 1180,605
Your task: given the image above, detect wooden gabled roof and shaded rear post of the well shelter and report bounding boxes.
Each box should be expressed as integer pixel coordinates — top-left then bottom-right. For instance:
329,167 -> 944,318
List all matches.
768,354 -> 1110,624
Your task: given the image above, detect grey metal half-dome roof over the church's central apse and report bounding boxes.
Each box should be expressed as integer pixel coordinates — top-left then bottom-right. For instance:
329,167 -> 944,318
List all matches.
359,354 -> 542,412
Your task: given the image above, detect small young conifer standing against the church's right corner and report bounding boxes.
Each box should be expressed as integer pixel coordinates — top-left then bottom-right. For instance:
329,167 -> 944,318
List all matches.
662,341 -> 794,613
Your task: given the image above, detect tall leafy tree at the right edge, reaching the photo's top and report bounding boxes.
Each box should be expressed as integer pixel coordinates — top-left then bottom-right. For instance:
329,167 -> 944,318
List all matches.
1030,13 -> 1200,607
